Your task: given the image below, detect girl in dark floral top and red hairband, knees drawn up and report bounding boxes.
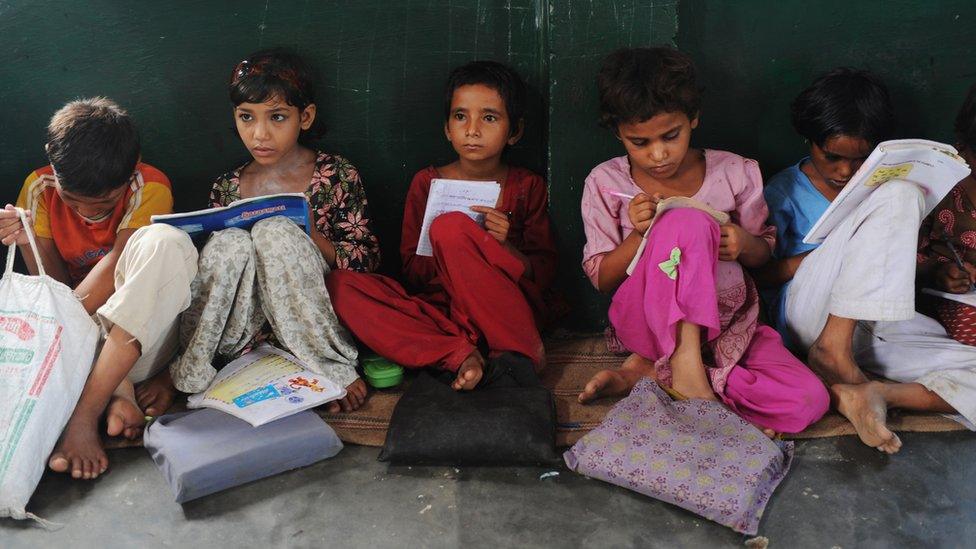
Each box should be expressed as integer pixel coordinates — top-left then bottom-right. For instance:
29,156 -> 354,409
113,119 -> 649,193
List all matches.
171,50 -> 379,411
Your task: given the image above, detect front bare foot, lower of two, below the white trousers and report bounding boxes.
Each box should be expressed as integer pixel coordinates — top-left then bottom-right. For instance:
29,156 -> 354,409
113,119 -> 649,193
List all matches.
830,381 -> 901,454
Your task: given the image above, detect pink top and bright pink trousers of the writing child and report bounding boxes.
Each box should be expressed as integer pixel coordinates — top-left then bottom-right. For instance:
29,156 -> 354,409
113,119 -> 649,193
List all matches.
582,150 -> 829,432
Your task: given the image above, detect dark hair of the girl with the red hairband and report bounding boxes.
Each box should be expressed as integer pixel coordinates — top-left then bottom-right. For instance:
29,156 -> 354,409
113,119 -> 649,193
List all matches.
229,48 -> 325,142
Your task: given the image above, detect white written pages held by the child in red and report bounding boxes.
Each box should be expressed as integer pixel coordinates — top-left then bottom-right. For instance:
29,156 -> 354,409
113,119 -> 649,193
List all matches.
416,179 -> 502,256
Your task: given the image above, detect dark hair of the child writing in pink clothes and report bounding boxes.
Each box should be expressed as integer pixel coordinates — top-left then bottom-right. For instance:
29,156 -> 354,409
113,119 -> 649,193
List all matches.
596,47 -> 701,129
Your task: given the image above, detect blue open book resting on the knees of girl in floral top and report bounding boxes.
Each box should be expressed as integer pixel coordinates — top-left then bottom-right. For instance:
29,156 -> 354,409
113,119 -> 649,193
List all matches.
150,193 -> 312,238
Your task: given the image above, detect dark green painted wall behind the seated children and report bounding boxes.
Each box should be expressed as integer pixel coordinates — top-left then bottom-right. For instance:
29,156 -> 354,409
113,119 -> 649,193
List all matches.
7,0 -> 976,328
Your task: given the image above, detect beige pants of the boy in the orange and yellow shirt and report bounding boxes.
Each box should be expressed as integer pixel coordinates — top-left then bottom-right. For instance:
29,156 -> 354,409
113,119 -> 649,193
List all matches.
95,225 -> 197,383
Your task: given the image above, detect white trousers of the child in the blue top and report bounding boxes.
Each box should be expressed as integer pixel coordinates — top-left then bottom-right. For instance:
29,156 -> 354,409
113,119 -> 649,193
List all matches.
785,180 -> 976,428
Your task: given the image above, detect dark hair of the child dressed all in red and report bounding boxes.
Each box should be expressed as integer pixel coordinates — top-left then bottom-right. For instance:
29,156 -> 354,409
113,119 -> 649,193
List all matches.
444,61 -> 526,135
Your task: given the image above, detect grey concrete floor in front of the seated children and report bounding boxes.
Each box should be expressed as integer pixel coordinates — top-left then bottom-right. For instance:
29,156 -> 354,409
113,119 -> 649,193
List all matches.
0,432 -> 976,549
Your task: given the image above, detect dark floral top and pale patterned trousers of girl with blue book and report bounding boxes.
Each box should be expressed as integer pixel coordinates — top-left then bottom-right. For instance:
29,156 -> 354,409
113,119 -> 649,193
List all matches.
170,152 -> 379,393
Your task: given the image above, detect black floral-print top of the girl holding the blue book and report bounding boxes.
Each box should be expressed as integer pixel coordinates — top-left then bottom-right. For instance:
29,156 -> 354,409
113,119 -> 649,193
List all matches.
210,151 -> 380,272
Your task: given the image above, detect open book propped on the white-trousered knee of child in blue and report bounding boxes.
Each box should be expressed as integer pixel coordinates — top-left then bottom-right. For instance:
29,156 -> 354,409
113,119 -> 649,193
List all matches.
803,139 -> 969,244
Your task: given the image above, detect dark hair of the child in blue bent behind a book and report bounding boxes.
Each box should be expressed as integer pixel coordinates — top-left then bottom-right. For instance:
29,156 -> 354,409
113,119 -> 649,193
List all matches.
790,67 -> 895,147
